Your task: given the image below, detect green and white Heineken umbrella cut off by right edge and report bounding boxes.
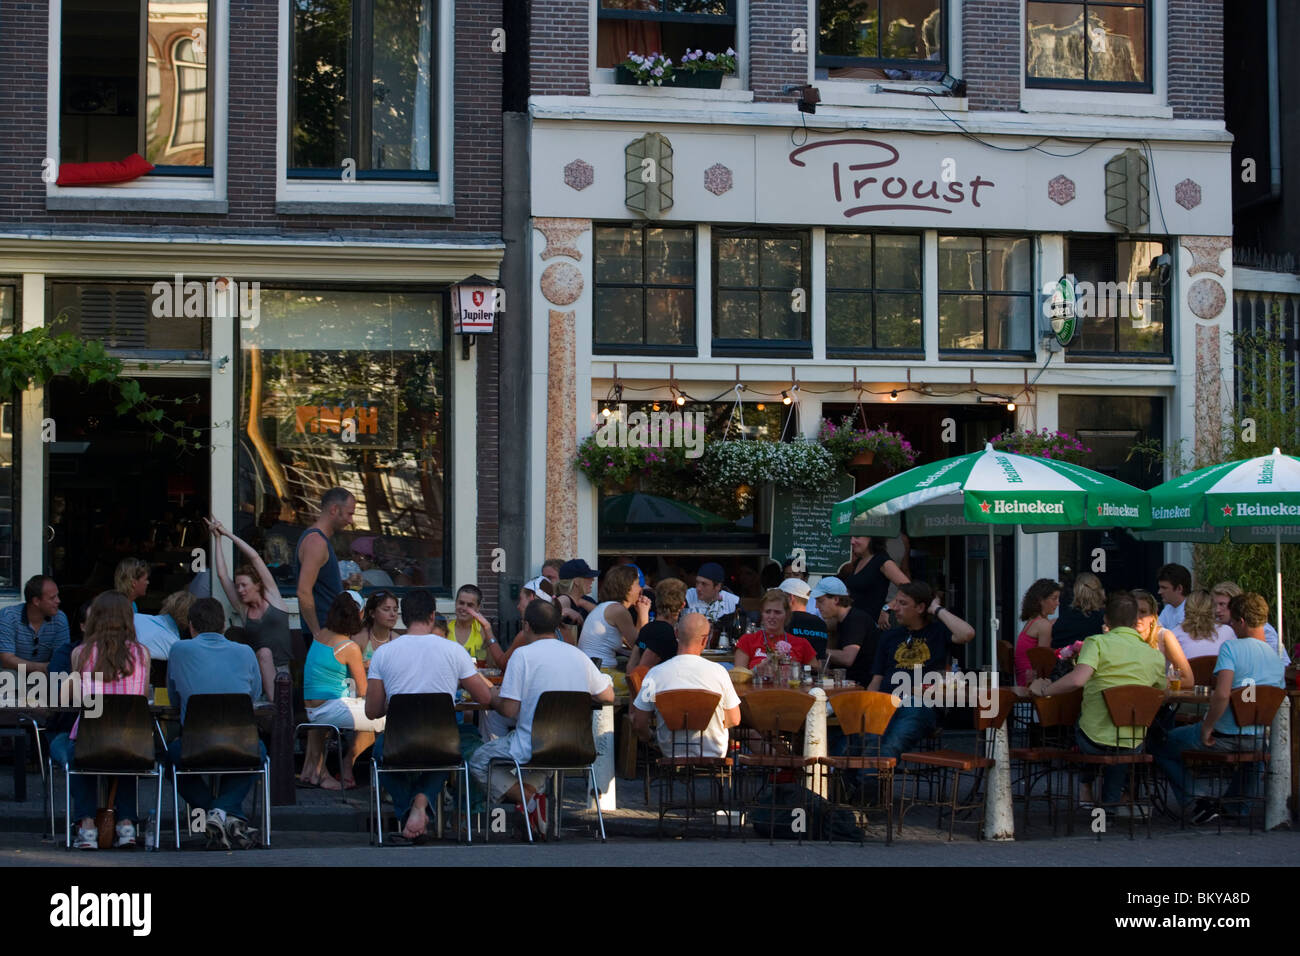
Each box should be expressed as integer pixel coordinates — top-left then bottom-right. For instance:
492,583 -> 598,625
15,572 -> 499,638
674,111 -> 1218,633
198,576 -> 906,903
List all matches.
1138,449 -> 1300,657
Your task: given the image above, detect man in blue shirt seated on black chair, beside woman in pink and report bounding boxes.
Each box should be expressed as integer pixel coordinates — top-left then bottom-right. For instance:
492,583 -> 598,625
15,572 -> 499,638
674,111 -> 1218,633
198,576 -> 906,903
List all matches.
166,597 -> 267,849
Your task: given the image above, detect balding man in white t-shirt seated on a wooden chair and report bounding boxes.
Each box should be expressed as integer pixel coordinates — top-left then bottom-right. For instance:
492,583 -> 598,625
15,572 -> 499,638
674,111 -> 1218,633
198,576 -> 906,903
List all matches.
632,614 -> 740,757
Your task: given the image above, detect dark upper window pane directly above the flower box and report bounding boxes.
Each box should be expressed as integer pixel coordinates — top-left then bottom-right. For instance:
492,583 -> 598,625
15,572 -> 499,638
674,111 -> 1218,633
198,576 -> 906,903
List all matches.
595,0 -> 738,68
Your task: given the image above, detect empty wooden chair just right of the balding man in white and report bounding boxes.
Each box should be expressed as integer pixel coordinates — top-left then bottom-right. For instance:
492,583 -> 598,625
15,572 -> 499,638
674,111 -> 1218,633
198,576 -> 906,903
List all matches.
736,688 -> 816,843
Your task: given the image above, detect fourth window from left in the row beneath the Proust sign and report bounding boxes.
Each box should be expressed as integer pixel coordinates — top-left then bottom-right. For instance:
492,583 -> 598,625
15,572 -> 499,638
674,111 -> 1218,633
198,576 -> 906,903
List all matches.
939,235 -> 1034,354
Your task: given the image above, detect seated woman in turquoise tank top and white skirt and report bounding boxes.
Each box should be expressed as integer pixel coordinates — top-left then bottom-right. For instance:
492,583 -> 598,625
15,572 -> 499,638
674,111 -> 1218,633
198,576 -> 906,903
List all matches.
299,594 -> 385,790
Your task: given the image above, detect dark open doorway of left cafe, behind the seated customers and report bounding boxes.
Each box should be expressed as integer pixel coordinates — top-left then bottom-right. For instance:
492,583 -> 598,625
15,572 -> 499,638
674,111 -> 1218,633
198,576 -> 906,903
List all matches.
44,377 -> 212,631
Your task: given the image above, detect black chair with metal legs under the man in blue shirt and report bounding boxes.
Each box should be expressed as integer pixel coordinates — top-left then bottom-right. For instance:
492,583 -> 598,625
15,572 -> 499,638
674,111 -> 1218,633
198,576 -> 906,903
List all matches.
172,693 -> 270,849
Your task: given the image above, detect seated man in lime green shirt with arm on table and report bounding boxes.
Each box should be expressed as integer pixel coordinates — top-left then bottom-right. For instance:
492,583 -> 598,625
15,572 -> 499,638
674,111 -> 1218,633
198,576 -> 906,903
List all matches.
1028,591 -> 1166,805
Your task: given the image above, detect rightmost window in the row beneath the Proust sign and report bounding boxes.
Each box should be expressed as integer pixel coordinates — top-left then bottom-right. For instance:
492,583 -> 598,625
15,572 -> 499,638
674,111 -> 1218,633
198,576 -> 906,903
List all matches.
1066,237 -> 1170,362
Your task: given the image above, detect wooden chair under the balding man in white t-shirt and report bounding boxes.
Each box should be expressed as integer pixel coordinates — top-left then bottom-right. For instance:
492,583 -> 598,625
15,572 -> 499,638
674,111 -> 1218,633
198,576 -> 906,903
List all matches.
654,691 -> 732,839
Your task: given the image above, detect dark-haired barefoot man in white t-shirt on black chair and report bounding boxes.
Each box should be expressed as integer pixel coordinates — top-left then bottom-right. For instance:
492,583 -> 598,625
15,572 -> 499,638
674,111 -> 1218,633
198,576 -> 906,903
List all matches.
365,588 -> 491,840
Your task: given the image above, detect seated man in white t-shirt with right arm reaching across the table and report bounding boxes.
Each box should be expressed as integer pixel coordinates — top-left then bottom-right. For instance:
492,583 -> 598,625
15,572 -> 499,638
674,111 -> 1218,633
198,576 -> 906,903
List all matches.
469,601 -> 614,836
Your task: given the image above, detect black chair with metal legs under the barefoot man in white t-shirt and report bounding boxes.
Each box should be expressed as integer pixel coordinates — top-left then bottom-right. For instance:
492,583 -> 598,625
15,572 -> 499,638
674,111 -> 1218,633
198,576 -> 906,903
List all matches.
371,693 -> 473,847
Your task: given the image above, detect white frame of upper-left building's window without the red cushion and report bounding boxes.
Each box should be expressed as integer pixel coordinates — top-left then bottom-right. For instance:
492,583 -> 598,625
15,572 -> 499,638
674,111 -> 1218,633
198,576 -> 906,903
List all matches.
276,0 -> 456,216
